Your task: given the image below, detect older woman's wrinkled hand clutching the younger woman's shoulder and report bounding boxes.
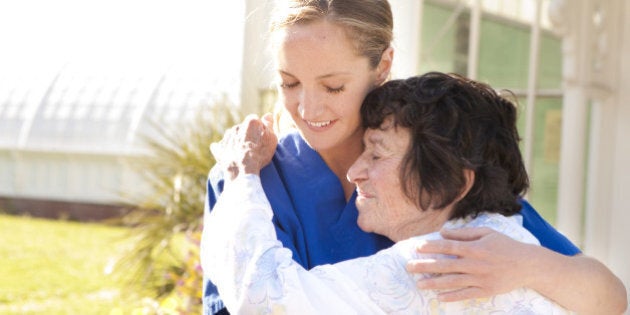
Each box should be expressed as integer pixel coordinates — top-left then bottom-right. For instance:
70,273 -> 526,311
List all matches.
210,114 -> 278,180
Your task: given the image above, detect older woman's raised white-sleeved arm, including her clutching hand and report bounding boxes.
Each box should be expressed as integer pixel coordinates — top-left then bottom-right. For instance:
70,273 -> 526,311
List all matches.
201,115 -> 377,314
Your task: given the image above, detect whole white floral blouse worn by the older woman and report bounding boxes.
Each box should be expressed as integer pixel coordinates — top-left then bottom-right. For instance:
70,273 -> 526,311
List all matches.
201,175 -> 568,314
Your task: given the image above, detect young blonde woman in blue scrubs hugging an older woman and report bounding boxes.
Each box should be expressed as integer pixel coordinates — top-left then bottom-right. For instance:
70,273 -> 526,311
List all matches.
201,0 -> 627,313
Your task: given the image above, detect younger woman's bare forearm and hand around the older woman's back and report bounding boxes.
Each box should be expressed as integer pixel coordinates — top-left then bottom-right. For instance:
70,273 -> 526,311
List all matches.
407,228 -> 627,314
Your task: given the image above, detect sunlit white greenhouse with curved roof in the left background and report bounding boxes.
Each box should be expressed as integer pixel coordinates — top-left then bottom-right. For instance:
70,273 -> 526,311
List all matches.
0,1 -> 242,216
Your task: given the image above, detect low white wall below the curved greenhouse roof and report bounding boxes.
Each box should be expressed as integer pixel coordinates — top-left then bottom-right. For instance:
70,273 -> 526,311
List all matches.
0,150 -> 142,204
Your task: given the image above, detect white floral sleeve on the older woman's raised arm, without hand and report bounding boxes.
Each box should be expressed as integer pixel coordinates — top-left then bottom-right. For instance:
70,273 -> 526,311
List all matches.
201,175 -> 382,314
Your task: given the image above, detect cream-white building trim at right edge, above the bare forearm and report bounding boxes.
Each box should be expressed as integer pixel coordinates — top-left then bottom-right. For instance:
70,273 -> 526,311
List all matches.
554,0 -> 630,302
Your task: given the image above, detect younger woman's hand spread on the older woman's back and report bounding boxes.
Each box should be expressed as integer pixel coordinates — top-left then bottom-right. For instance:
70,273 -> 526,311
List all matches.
407,228 -> 536,302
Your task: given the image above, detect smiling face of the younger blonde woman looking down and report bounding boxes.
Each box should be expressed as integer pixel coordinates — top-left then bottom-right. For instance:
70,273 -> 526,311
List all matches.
277,21 -> 382,152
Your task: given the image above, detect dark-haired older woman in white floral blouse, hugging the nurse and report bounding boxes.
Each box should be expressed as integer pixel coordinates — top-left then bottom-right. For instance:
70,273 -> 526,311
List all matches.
202,73 -> 566,314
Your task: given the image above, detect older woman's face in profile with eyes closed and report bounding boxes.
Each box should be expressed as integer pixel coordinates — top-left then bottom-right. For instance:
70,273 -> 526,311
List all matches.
348,119 -> 448,241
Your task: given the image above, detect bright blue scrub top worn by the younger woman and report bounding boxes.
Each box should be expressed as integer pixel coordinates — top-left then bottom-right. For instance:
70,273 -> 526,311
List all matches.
204,132 -> 580,314
